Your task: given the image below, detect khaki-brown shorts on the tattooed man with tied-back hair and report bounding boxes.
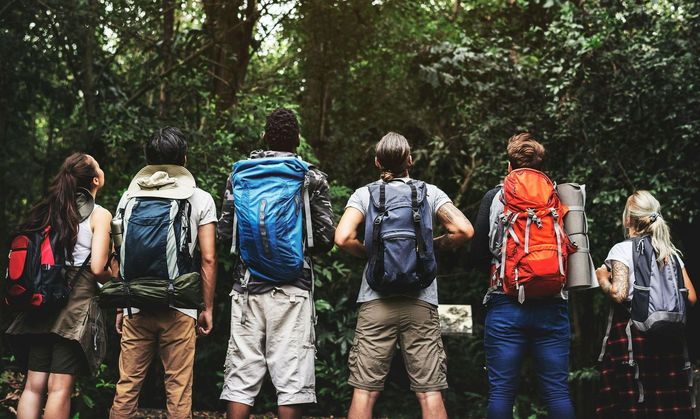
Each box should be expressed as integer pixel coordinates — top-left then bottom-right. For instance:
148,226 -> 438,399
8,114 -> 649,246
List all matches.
348,297 -> 447,392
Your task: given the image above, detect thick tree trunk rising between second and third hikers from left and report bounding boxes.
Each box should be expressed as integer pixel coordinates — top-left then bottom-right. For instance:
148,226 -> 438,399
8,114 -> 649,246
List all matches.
204,0 -> 259,110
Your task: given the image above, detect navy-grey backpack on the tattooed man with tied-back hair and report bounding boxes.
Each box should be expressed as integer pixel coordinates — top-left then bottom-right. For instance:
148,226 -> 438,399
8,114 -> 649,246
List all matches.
365,180 -> 437,294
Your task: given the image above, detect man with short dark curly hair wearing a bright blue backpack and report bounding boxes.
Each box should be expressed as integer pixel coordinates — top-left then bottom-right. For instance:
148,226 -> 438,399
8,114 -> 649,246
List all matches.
218,108 -> 335,418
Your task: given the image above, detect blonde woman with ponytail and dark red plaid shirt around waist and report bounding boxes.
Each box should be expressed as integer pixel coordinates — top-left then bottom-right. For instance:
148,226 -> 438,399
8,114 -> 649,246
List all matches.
596,191 -> 697,418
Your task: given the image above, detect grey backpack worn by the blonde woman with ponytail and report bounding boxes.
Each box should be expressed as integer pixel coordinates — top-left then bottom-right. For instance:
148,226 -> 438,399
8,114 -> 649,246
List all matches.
630,236 -> 688,334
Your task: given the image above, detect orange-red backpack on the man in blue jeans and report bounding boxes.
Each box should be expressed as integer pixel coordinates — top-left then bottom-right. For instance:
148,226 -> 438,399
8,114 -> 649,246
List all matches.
492,168 -> 575,303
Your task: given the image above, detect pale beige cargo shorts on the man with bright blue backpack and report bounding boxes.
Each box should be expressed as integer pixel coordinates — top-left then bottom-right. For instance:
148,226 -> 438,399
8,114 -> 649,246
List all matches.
220,285 -> 316,406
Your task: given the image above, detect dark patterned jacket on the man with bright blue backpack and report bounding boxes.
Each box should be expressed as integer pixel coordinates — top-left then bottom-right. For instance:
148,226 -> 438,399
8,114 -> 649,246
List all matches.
217,150 -> 335,294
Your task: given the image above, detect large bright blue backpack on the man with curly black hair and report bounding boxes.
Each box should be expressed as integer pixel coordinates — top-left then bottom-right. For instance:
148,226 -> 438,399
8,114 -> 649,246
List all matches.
231,157 -> 313,286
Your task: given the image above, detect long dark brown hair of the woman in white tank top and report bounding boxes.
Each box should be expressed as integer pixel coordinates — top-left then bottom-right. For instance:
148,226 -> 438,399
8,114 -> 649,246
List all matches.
17,153 -> 97,262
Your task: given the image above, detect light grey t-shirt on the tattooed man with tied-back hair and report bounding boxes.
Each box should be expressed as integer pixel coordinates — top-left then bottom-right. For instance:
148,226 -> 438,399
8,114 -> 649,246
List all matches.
345,177 -> 452,305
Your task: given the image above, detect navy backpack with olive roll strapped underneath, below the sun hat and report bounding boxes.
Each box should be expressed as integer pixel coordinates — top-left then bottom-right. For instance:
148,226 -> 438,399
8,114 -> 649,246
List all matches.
99,196 -> 202,313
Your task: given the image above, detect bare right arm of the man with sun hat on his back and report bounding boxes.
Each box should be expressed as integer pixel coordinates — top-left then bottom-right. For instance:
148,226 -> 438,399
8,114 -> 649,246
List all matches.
197,223 -> 216,335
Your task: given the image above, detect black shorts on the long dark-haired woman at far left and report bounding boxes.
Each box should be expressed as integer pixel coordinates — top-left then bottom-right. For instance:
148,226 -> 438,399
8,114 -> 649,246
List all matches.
27,334 -> 89,375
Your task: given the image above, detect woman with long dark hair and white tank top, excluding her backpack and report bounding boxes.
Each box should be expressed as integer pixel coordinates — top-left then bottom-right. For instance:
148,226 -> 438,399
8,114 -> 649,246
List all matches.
6,153 -> 112,419
